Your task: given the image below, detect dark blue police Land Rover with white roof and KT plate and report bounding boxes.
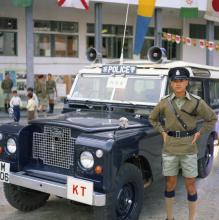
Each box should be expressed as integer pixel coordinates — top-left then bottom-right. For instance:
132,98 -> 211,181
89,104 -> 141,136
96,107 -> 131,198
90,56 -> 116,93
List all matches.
0,47 -> 219,220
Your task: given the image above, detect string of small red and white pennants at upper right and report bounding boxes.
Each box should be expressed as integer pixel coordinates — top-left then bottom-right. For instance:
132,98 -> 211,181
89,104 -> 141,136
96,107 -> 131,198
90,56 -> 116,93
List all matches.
163,32 -> 219,52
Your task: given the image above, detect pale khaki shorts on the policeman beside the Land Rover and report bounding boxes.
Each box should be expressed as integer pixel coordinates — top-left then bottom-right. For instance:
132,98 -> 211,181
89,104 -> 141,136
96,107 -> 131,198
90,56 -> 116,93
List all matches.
162,154 -> 198,178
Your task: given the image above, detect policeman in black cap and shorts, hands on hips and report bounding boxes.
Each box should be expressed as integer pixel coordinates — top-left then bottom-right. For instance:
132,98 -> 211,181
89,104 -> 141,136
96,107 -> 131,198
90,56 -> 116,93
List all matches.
149,67 -> 217,220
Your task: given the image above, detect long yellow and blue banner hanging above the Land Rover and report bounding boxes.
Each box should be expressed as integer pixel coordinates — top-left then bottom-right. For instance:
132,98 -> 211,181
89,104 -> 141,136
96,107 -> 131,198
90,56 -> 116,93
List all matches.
134,0 -> 156,55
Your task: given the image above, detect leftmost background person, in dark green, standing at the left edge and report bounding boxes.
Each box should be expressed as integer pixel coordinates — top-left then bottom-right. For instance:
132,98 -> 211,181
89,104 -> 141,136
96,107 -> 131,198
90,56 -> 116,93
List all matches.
1,73 -> 13,113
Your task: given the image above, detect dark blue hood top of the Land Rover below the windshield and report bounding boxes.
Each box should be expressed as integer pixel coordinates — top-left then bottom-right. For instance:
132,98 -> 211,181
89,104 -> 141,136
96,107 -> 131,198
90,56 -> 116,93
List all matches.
31,112 -> 149,132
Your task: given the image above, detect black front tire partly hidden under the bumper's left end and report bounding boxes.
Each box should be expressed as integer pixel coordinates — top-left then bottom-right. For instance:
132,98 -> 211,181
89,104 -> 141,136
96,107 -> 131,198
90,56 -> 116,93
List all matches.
4,183 -> 49,212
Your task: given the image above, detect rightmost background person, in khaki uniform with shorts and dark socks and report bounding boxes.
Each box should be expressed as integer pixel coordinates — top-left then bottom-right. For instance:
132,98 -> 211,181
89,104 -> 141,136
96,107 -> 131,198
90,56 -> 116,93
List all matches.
46,73 -> 57,113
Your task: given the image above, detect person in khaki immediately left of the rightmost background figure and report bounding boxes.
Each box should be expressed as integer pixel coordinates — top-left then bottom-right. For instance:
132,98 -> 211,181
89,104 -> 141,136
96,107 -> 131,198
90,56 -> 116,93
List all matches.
34,75 -> 47,112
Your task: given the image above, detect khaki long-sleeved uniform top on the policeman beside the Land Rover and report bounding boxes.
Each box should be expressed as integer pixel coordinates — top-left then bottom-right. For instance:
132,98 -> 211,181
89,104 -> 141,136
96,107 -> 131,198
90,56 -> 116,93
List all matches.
149,92 -> 217,155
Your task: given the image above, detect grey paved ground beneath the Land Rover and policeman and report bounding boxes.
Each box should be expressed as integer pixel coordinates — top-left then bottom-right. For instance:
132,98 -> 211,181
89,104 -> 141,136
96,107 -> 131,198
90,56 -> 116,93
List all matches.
0,114 -> 219,220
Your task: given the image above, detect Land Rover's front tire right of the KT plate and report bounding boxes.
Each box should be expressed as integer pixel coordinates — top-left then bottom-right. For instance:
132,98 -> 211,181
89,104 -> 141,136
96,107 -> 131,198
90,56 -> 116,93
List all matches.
94,163 -> 144,220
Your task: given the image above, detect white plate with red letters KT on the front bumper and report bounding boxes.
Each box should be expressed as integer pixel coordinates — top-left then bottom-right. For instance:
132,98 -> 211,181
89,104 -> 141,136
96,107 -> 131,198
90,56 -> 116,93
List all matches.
67,176 -> 94,205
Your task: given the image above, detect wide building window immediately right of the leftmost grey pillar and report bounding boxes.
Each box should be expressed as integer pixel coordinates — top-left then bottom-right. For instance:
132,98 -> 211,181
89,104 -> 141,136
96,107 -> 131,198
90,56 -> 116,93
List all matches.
34,20 -> 78,57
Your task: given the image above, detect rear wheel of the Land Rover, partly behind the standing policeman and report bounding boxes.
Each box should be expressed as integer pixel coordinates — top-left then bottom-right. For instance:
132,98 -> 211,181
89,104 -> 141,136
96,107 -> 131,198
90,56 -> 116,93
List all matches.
198,135 -> 214,178
